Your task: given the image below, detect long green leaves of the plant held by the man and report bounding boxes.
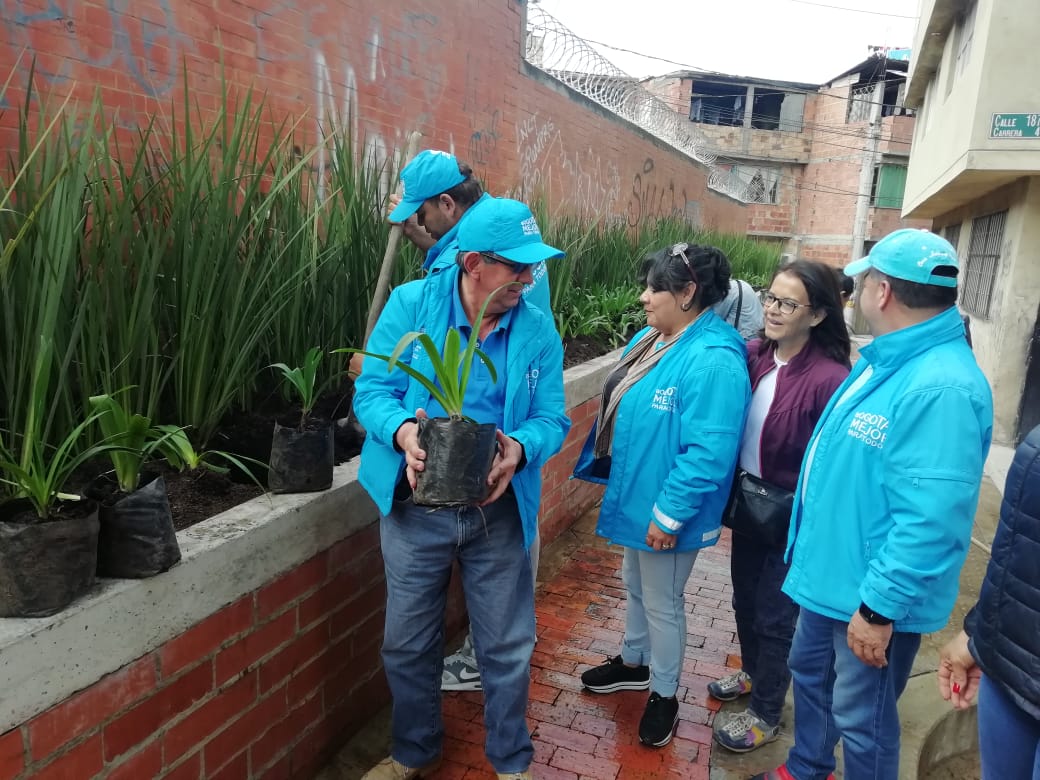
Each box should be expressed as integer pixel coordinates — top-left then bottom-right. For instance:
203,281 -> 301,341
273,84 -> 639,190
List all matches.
333,285 -> 511,419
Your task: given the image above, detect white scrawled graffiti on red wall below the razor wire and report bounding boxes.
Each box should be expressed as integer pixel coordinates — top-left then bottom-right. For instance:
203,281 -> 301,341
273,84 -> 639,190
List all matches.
517,113 -> 621,214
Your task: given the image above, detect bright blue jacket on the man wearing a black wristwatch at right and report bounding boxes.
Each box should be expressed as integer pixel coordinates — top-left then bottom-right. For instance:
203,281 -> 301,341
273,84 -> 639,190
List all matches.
783,308 -> 993,633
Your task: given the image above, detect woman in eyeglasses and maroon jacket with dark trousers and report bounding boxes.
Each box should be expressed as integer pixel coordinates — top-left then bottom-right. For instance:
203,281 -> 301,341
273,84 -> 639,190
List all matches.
707,260 -> 850,753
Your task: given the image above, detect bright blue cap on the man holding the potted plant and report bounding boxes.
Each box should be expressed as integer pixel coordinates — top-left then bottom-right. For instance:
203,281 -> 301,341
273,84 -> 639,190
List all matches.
459,198 -> 565,264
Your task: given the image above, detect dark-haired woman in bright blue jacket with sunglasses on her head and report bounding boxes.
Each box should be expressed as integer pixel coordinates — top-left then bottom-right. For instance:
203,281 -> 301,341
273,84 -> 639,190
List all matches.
575,243 -> 751,747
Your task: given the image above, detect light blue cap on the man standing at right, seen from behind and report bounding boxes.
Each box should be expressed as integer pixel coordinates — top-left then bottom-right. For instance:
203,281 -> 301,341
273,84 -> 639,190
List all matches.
844,228 -> 960,287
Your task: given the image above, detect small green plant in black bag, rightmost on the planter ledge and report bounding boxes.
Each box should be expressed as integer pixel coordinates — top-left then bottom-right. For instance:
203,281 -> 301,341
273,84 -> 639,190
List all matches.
267,346 -> 338,493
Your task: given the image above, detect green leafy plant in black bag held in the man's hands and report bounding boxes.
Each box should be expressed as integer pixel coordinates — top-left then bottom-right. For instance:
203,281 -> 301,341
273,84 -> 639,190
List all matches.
335,285 -> 510,506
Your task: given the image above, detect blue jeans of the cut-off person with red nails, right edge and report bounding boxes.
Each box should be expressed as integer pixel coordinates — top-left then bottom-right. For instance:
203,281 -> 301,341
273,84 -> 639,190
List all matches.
978,675 -> 1040,780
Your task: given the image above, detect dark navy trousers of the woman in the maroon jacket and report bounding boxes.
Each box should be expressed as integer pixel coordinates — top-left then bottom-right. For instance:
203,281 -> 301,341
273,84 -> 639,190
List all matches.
729,532 -> 798,726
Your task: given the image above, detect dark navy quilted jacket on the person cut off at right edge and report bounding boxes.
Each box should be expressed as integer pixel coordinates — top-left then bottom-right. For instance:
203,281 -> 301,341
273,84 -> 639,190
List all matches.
964,426 -> 1040,721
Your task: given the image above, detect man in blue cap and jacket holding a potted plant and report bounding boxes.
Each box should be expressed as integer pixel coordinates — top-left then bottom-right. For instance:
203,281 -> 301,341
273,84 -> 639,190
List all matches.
355,199 -> 570,780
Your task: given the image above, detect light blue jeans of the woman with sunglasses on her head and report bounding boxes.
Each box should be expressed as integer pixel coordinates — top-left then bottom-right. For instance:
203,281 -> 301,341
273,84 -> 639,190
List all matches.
621,547 -> 698,697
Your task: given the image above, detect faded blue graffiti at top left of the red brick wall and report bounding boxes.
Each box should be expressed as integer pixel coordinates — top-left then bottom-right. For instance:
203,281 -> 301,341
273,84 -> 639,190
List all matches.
0,0 -> 186,108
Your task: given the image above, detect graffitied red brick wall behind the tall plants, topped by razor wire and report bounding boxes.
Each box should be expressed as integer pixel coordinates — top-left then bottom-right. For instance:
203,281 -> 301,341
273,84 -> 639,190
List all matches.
0,0 -> 746,233
